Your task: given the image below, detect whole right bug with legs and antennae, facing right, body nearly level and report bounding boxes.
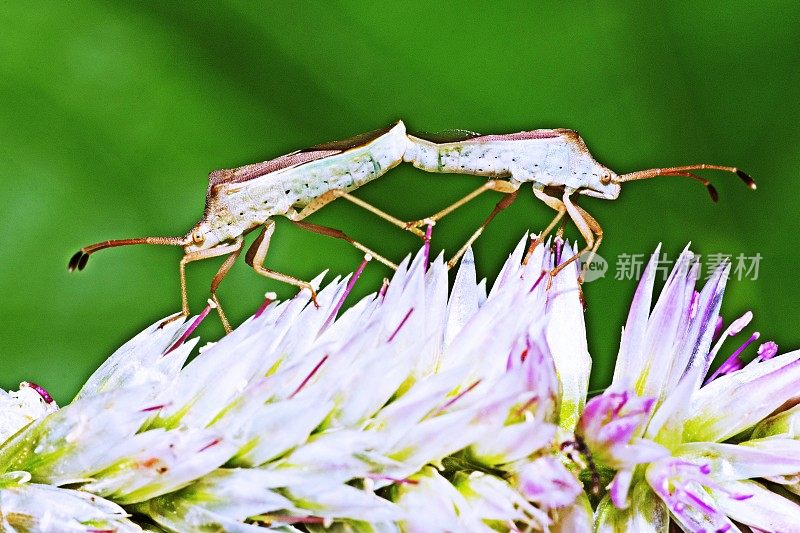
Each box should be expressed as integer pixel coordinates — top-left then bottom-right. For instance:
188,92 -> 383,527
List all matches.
403,129 -> 756,280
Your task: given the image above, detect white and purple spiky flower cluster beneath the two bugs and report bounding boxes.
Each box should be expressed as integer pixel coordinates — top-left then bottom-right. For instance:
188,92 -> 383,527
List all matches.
0,239 -> 800,532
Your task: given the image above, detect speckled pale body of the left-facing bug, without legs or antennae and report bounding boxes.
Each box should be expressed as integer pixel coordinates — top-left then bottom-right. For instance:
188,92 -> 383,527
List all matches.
190,122 -> 407,249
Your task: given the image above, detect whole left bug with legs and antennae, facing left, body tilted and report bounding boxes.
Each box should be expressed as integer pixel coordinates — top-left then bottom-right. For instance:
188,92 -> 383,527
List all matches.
68,121 -> 424,332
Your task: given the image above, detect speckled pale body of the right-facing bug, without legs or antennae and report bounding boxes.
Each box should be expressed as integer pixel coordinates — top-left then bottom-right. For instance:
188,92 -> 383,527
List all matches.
403,129 -> 619,200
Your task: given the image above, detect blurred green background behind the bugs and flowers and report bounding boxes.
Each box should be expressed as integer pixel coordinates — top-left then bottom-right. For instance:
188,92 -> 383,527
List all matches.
0,0 -> 800,402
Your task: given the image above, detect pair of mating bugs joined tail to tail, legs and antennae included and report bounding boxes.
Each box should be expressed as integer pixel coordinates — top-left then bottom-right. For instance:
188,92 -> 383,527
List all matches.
69,121 -> 756,331
